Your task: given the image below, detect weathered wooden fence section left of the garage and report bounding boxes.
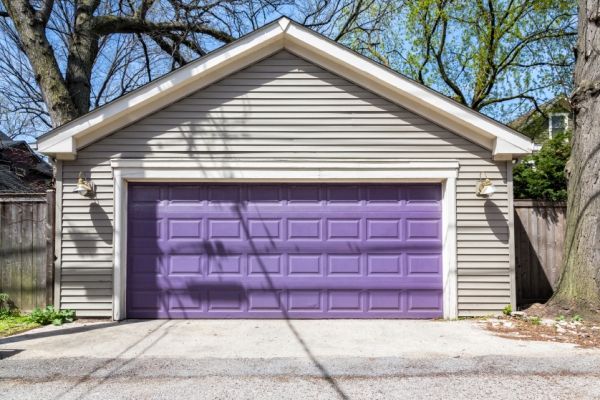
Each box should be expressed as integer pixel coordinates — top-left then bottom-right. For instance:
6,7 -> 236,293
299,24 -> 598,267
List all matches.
0,191 -> 55,311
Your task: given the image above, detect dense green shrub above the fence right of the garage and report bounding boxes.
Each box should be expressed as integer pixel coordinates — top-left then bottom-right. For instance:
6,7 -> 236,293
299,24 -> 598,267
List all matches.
513,133 -> 571,201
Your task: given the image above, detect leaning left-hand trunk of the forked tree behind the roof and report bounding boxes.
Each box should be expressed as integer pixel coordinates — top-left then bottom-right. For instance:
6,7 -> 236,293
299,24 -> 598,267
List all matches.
3,0 -> 80,127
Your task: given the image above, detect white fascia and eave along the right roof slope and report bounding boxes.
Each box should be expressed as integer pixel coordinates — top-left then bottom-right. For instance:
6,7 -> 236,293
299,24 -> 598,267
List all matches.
285,24 -> 532,155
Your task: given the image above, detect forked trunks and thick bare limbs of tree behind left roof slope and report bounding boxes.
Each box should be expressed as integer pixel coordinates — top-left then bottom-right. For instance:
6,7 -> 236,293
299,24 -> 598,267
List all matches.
0,0 -> 244,127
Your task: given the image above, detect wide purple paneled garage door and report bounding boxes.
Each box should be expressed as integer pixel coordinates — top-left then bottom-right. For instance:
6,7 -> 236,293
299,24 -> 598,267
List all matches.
127,183 -> 442,318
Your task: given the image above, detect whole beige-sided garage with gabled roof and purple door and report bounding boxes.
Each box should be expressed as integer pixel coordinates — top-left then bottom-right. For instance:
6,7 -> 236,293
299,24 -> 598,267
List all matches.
38,18 -> 532,320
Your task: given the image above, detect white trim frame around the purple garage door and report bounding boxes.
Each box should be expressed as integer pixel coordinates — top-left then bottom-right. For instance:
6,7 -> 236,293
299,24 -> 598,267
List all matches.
111,159 -> 459,320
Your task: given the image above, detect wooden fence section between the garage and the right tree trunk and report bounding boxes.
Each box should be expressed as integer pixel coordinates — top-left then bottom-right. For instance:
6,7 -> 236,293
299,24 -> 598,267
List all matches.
514,200 -> 567,305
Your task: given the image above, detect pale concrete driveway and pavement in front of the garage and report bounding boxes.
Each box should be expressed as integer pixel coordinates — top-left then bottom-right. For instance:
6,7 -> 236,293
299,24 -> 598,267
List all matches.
0,320 -> 600,400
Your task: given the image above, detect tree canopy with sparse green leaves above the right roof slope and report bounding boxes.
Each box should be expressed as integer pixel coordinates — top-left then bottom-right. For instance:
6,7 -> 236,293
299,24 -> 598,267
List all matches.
361,0 -> 577,122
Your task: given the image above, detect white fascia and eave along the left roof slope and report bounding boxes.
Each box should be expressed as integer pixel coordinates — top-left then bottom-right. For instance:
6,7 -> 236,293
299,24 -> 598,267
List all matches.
38,23 -> 283,158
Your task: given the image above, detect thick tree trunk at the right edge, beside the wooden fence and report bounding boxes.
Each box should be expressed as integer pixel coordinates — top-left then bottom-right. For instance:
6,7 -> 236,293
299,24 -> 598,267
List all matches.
550,0 -> 600,311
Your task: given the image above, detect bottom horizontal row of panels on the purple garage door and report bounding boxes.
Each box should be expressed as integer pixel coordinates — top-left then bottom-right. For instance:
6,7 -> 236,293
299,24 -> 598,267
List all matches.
125,287 -> 441,318
